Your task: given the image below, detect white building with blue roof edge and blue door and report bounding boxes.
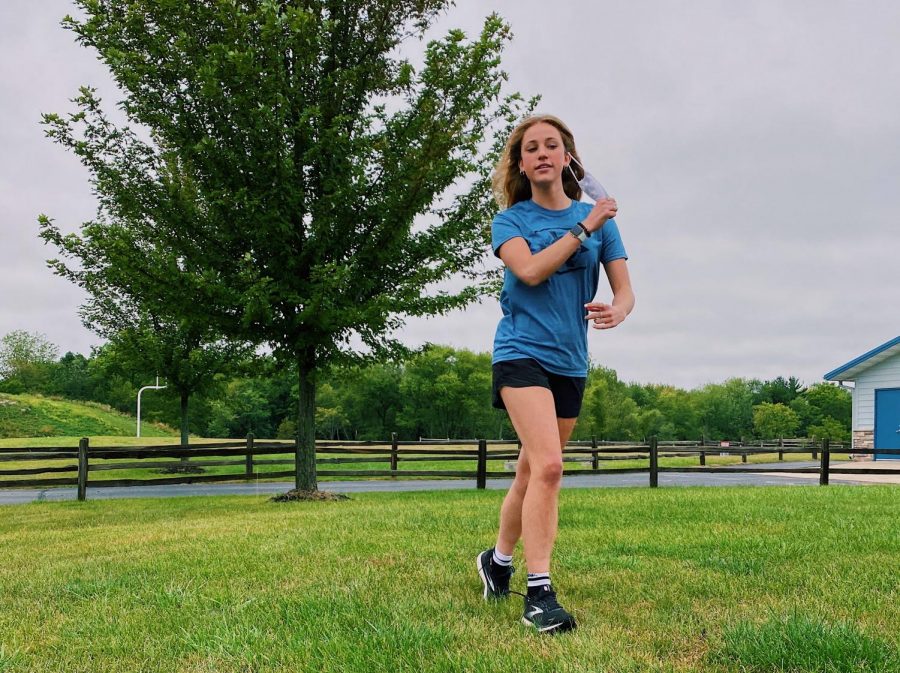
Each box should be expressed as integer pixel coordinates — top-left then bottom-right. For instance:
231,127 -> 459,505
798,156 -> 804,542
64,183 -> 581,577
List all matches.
825,336 -> 900,460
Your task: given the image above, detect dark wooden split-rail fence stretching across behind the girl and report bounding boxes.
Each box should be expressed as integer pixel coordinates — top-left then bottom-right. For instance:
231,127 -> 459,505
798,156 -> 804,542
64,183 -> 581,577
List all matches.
0,435 -> 900,500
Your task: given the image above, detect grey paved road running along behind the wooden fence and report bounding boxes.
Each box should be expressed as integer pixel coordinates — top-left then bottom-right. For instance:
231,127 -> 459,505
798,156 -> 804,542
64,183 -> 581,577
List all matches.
0,461 -> 900,505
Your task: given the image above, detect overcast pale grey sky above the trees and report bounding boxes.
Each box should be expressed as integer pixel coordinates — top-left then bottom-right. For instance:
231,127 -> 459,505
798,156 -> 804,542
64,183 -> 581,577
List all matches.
0,0 -> 900,387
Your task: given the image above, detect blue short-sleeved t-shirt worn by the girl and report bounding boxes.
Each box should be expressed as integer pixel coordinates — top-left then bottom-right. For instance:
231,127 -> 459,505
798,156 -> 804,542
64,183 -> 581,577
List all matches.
491,200 -> 628,376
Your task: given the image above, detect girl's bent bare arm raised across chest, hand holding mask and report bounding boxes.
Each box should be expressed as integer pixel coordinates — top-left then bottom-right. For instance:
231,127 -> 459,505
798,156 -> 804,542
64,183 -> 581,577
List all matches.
498,199 -> 617,286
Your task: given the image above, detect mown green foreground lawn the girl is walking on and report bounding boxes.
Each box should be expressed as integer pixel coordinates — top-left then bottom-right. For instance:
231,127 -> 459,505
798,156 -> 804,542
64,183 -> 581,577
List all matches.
0,486 -> 900,673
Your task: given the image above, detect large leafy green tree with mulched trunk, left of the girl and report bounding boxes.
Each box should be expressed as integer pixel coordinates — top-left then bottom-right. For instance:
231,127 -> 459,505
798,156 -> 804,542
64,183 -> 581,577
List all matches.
43,0 -> 528,489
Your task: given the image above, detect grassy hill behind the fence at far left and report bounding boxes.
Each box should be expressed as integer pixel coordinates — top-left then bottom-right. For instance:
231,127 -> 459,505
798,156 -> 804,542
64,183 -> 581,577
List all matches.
0,393 -> 177,438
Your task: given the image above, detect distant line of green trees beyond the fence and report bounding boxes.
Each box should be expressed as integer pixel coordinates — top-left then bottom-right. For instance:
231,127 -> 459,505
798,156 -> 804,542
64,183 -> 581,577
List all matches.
0,332 -> 850,441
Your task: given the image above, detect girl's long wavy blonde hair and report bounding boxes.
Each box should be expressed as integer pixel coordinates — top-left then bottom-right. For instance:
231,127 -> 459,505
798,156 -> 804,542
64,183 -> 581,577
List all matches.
491,115 -> 584,208
